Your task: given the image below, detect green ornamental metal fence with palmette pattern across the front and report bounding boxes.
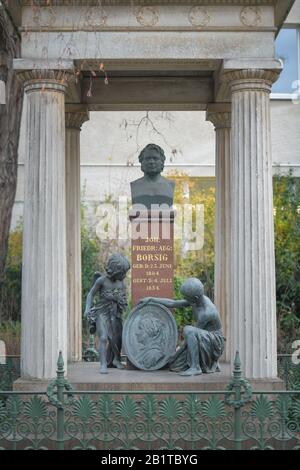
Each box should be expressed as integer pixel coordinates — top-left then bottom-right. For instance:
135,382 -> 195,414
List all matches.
0,354 -> 300,450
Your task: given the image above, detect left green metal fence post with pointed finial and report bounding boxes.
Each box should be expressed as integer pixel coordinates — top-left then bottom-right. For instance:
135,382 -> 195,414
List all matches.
47,351 -> 72,450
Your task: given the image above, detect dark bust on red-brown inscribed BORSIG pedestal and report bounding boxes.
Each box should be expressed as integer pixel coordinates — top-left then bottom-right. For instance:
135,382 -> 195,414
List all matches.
129,144 -> 175,305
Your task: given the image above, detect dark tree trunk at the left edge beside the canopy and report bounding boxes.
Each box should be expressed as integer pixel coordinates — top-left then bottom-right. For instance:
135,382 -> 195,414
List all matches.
0,1 -> 23,281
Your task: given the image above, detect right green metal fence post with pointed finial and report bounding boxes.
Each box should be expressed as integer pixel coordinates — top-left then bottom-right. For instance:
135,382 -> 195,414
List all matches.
225,351 -> 252,450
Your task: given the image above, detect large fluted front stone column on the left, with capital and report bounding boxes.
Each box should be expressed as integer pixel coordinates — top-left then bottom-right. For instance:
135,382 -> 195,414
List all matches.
20,70 -> 67,379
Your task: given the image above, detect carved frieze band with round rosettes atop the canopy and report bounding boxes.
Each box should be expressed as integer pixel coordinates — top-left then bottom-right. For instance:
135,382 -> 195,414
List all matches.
22,2 -> 274,33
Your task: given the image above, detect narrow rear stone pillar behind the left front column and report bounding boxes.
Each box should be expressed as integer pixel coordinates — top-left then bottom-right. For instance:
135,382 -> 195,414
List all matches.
66,106 -> 89,362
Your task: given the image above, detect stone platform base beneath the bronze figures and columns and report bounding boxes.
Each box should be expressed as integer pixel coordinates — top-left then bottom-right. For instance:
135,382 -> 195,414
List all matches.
14,362 -> 284,392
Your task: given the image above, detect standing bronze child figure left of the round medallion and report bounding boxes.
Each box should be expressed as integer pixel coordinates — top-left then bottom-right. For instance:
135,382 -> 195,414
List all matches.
84,253 -> 130,374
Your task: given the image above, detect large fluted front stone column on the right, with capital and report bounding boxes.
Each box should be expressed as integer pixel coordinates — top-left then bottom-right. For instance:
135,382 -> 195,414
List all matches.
223,69 -> 278,378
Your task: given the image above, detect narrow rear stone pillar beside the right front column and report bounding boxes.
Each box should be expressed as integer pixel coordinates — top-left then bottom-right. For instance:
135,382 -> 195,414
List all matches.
206,103 -> 231,361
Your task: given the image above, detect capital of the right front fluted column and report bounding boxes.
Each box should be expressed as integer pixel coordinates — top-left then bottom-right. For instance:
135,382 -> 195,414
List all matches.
221,68 -> 281,93
